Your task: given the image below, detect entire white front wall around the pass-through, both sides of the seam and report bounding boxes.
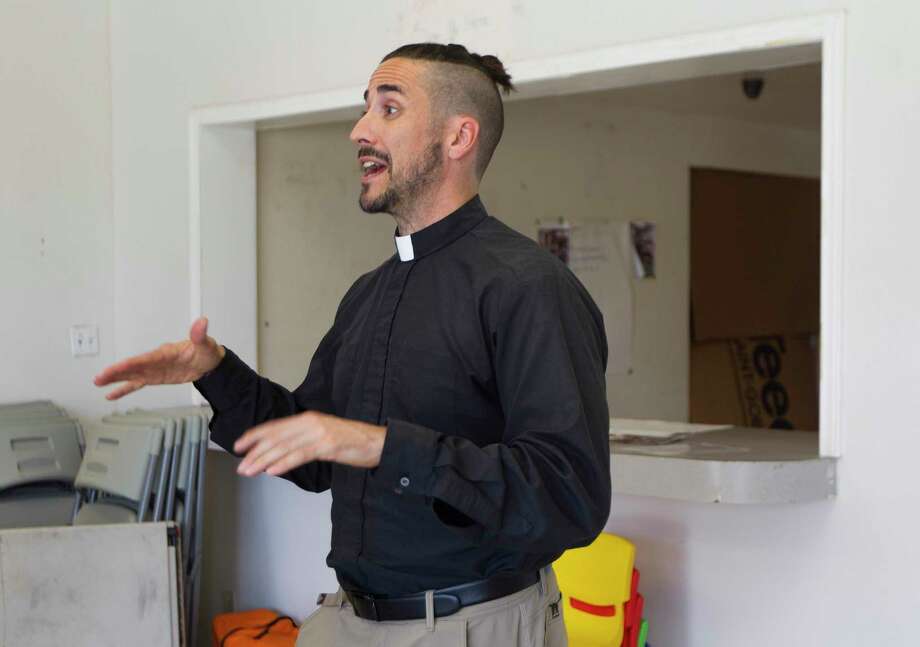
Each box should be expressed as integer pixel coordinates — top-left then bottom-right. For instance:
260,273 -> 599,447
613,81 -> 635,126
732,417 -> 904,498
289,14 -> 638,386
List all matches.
0,0 -> 904,647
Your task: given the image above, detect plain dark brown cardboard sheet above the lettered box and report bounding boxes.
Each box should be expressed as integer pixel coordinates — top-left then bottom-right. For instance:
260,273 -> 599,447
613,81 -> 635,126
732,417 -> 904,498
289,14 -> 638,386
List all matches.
690,168 -> 821,341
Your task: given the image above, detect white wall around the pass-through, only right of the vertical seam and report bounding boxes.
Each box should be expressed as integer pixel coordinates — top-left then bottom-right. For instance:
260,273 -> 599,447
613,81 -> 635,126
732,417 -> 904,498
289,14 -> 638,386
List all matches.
104,0 -> 920,647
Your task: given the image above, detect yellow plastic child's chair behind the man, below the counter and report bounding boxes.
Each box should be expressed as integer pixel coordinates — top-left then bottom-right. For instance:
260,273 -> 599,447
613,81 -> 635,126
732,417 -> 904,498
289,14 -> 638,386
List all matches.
553,532 -> 636,647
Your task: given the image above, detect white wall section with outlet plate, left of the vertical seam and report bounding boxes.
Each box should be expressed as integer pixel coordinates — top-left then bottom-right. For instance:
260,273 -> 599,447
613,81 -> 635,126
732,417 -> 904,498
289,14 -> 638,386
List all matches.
0,2 -> 114,417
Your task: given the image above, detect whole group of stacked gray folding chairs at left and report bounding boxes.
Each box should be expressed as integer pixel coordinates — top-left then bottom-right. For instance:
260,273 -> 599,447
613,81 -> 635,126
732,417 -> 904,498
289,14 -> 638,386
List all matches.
0,400 -> 210,645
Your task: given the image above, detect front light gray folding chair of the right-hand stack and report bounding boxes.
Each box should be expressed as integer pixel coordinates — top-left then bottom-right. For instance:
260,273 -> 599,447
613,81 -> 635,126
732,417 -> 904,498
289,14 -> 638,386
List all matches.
74,424 -> 164,525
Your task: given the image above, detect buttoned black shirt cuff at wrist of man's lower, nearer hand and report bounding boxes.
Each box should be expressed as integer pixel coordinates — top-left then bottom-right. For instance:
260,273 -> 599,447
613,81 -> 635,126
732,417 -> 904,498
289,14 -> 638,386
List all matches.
374,418 -> 439,496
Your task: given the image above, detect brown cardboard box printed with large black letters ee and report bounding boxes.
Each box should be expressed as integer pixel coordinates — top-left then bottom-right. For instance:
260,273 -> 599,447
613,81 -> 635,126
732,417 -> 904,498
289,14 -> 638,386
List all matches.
690,335 -> 819,431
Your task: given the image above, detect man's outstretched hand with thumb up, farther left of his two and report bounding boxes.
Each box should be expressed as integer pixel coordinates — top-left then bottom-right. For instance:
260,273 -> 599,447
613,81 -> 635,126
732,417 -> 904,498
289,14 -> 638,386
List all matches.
93,317 -> 225,400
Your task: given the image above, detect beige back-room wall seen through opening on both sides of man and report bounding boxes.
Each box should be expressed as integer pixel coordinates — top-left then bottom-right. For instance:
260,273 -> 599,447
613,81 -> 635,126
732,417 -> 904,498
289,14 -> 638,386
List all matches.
258,90 -> 820,420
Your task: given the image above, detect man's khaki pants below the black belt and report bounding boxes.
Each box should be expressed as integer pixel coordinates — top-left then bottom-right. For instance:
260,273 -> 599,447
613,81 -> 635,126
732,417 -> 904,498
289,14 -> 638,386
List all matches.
297,568 -> 568,647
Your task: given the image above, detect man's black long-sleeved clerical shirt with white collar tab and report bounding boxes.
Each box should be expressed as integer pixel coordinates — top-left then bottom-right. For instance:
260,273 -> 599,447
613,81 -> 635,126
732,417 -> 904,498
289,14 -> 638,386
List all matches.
196,196 -> 611,595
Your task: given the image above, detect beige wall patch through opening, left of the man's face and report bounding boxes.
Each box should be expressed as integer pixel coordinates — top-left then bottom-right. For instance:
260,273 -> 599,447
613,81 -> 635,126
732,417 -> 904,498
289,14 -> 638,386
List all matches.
256,123 -> 396,382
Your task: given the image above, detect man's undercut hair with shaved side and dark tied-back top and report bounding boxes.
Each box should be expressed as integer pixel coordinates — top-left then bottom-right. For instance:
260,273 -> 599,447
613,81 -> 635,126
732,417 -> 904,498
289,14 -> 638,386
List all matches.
380,43 -> 514,180
